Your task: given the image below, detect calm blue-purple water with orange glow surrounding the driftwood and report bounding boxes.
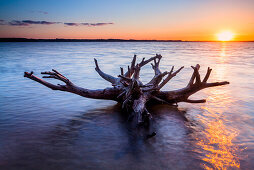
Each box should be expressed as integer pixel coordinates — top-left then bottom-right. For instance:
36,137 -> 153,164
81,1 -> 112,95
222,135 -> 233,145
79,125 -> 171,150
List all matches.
0,42 -> 254,169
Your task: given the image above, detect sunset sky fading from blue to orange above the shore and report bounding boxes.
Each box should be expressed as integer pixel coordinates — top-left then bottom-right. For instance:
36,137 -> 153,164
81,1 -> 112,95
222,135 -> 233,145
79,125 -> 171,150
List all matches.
0,0 -> 254,41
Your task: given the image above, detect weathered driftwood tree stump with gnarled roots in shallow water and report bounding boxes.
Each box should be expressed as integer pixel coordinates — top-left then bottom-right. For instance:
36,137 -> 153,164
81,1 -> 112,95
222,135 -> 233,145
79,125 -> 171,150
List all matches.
24,54 -> 229,135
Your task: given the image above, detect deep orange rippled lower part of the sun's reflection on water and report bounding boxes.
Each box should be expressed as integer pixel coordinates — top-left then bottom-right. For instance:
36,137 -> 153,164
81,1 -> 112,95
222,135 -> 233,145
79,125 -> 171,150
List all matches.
197,108 -> 240,169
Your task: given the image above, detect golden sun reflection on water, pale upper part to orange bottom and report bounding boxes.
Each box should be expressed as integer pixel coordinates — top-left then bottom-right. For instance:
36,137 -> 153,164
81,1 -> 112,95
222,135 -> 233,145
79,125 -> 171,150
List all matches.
196,78 -> 240,169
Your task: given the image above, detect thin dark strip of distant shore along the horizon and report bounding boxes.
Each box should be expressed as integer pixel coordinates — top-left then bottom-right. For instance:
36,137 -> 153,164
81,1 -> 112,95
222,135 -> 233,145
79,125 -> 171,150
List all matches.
0,38 -> 254,42
